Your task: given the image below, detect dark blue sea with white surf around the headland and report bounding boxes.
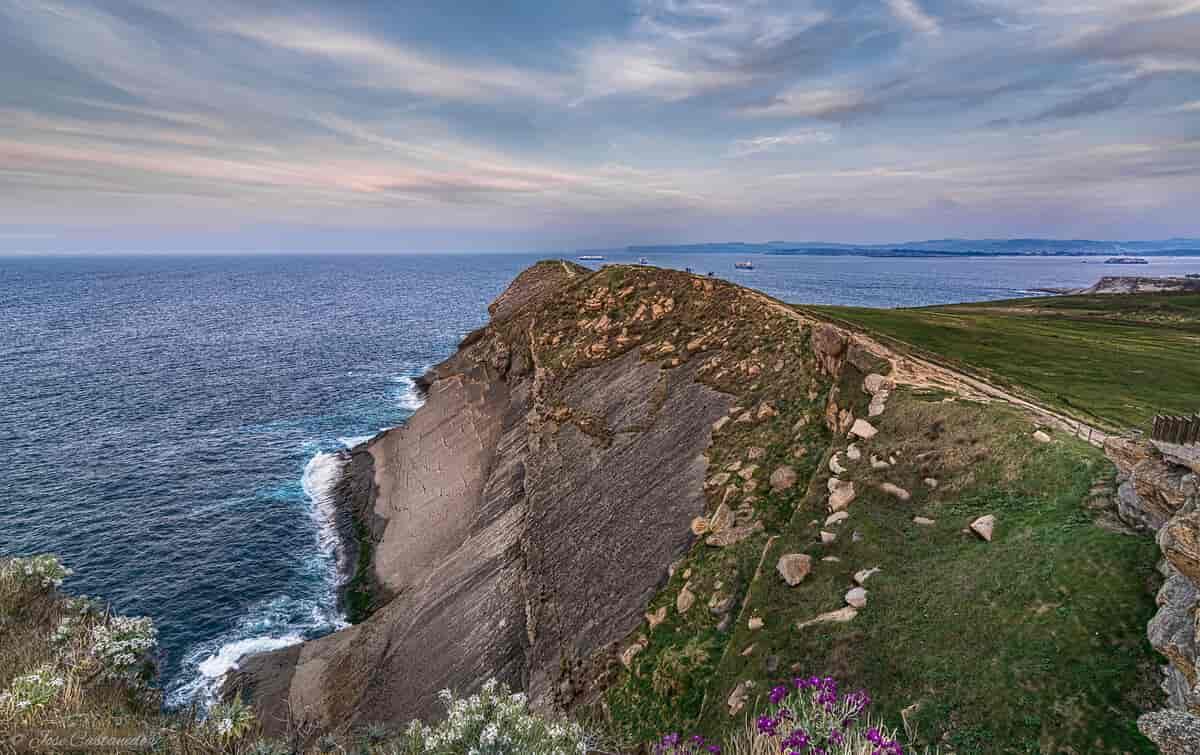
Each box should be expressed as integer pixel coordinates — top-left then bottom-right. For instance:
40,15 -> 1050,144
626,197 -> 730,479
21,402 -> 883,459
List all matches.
0,254 -> 1200,705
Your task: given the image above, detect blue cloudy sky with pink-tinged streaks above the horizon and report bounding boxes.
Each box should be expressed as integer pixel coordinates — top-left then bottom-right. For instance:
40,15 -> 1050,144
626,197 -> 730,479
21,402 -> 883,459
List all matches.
0,0 -> 1200,252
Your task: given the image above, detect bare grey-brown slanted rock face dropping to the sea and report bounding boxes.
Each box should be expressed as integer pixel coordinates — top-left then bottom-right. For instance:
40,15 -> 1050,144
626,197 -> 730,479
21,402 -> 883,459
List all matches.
227,262 -> 733,733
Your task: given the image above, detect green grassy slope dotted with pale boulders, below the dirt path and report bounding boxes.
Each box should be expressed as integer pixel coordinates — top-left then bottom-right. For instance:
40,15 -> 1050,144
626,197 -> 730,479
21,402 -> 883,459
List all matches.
704,395 -> 1157,754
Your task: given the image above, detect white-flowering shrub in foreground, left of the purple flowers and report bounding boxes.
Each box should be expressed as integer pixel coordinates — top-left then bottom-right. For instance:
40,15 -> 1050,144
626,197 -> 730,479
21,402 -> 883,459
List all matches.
398,679 -> 589,755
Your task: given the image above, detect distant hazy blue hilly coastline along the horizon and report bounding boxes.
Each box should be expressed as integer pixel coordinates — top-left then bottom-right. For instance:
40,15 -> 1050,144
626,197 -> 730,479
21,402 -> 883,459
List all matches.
577,239 -> 1200,257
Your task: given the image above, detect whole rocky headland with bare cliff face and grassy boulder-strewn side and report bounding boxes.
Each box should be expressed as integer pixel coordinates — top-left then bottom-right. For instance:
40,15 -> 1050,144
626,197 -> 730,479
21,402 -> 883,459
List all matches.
227,262 -> 1175,753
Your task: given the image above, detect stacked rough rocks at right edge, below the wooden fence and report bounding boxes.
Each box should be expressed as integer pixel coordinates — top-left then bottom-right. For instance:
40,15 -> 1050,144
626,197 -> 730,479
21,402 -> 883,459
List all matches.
1105,441 -> 1200,755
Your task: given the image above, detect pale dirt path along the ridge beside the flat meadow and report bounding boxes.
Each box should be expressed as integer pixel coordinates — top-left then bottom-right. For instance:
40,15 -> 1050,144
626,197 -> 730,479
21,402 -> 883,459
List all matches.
751,292 -> 1111,448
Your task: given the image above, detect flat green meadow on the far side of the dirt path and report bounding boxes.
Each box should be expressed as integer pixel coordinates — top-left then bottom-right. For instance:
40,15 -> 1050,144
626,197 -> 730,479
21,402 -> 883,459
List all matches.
806,294 -> 1200,429
